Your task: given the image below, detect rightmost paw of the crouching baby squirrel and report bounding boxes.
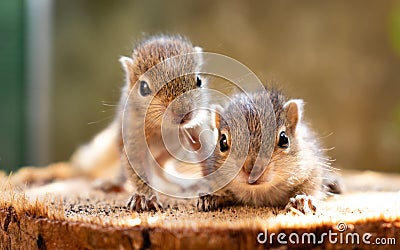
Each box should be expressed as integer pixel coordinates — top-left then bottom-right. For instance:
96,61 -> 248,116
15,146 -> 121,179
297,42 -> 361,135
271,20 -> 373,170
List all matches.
285,194 -> 317,215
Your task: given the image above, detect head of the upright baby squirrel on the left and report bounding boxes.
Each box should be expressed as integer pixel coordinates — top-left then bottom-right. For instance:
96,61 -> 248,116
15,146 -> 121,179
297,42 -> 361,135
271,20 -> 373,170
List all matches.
120,36 -> 205,127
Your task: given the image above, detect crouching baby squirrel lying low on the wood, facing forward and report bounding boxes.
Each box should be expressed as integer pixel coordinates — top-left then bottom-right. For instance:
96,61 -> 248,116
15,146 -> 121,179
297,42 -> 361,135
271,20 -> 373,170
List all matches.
198,89 -> 337,212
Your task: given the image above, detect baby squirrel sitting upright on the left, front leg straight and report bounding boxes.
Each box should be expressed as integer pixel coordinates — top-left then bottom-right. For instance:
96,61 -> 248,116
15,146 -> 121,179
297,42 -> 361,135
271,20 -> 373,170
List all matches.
72,35 -> 207,211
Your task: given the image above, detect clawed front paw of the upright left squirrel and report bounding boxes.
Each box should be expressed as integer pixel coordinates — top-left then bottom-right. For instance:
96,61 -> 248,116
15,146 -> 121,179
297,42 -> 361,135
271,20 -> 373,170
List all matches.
126,193 -> 163,212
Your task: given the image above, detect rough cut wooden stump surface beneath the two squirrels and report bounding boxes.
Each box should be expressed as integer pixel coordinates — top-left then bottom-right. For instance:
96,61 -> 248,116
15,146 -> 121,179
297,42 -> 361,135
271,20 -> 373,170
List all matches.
0,164 -> 400,249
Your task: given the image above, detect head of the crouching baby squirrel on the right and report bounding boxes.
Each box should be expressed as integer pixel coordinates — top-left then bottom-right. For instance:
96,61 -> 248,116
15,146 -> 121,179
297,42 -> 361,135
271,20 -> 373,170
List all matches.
205,91 -> 303,189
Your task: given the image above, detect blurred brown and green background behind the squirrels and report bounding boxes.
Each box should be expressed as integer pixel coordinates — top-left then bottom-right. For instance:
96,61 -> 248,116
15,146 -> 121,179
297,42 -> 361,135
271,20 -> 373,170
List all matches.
0,0 -> 400,172
